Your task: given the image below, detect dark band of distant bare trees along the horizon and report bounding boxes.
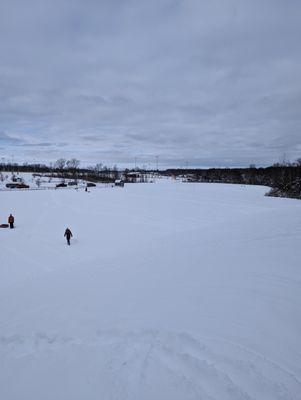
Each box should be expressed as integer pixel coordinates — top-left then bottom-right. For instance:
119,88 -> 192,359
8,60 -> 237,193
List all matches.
0,158 -> 301,199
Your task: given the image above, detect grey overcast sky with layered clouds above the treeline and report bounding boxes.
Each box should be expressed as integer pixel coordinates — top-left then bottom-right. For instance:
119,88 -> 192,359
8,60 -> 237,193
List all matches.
0,0 -> 301,166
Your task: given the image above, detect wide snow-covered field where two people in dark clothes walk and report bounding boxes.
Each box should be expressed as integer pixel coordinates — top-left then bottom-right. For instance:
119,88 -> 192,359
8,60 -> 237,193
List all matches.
0,180 -> 301,400
